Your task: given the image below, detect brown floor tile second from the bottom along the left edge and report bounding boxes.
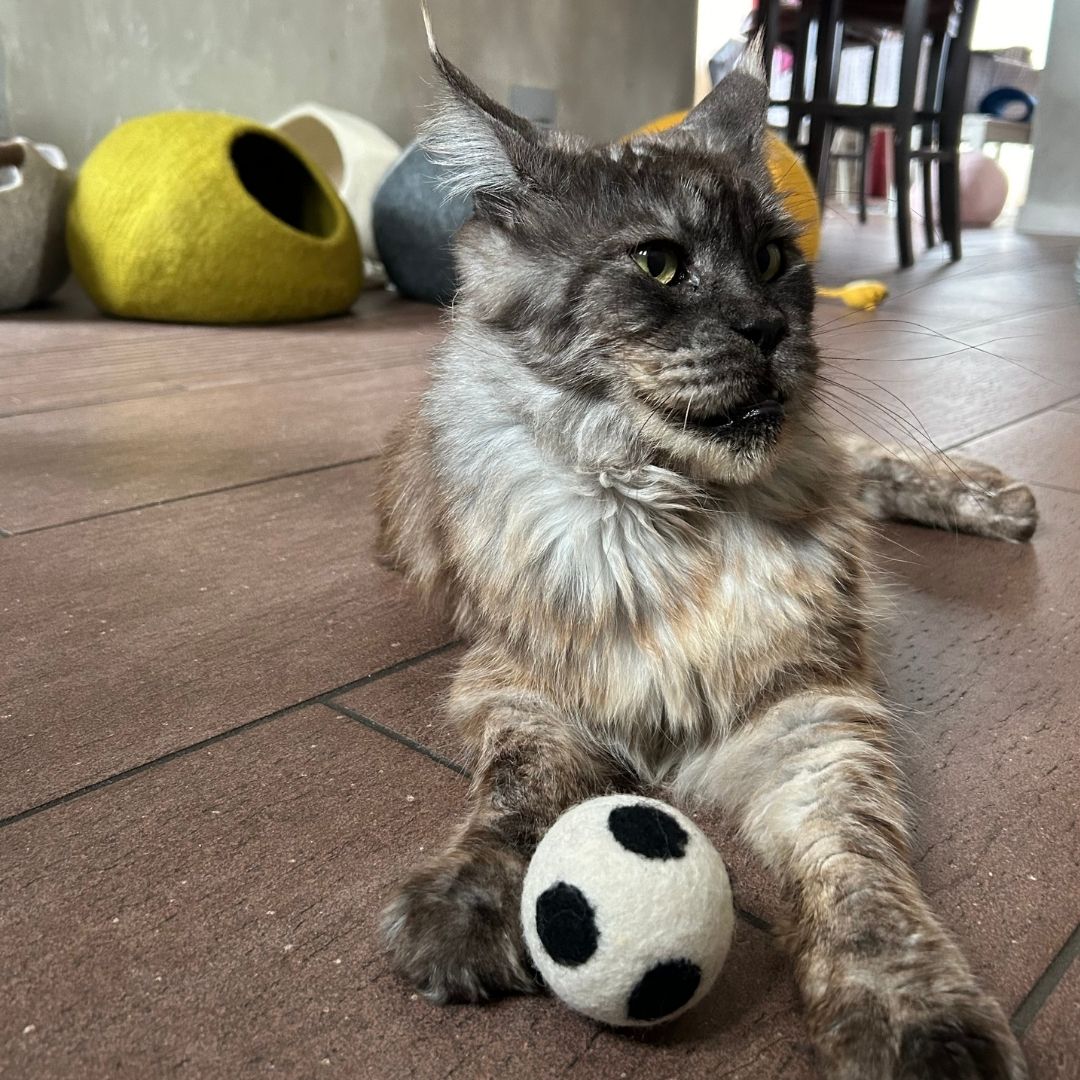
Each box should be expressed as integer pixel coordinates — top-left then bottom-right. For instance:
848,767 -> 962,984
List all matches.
0,462 -> 449,816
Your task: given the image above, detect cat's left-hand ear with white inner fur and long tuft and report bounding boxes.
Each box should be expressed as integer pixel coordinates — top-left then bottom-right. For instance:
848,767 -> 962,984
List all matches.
420,4 -> 544,214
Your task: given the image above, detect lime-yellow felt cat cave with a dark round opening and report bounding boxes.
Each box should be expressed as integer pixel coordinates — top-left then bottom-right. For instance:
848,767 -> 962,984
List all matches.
67,111 -> 363,323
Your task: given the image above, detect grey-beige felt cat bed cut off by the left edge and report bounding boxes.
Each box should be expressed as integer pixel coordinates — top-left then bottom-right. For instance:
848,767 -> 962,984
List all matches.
0,138 -> 70,311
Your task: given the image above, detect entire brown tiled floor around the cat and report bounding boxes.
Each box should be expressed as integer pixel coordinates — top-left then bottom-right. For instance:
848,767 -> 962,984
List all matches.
0,216 -> 1080,1080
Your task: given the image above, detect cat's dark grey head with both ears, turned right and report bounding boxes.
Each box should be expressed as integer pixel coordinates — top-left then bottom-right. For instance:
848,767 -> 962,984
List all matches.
424,27 -> 816,483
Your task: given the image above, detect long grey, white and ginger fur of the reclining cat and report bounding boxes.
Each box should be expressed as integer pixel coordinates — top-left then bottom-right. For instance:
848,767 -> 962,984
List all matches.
380,27 -> 1035,1080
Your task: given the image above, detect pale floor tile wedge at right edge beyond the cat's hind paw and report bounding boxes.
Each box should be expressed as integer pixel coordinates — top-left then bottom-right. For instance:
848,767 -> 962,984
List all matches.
963,406 -> 1080,491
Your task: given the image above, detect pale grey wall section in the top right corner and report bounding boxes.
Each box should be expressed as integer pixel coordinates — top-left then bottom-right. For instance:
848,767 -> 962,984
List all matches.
1016,0 -> 1080,237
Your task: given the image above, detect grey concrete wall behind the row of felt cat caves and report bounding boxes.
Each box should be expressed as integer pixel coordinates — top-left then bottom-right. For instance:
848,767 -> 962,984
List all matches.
0,0 -> 697,161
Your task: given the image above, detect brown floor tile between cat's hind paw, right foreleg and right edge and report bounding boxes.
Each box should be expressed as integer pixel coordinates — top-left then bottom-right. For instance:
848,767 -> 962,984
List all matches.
882,489 -> 1080,1009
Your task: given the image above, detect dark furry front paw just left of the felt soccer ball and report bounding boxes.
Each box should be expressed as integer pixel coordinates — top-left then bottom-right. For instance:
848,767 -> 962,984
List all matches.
382,845 -> 539,1004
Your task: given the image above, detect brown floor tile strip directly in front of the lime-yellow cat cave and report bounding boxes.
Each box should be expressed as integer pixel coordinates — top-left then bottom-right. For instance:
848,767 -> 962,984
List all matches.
0,294 -> 443,416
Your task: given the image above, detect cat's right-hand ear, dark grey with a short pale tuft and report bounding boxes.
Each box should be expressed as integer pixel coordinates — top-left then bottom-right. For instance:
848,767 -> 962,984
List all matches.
673,35 -> 769,160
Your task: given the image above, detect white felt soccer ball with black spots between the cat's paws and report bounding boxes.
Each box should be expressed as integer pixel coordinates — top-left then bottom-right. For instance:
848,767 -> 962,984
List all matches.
522,795 -> 734,1027
